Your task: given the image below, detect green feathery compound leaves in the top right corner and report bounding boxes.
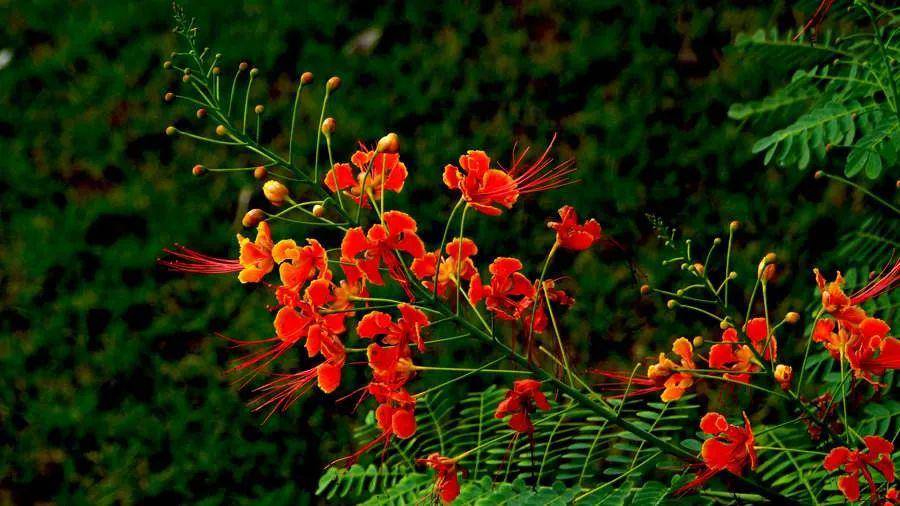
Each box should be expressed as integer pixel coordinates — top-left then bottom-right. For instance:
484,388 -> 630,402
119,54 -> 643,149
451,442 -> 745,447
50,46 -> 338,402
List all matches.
728,7 -> 900,179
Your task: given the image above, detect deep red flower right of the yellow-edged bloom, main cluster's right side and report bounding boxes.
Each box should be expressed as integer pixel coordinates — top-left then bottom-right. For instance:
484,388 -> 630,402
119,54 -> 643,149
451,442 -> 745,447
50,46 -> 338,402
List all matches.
469,257 -> 535,320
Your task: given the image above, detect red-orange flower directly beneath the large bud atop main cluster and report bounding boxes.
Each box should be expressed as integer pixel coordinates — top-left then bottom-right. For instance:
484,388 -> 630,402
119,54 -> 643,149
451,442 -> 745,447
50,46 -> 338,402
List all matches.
325,146 -> 407,207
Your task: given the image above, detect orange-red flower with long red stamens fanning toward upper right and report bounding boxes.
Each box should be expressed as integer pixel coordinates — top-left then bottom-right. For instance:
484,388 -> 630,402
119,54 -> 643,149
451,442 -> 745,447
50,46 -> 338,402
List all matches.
444,135 -> 575,216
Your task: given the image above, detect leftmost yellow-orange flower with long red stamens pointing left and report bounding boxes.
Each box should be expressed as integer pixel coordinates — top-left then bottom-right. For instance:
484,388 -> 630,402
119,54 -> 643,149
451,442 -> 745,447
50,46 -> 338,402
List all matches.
159,221 -> 275,283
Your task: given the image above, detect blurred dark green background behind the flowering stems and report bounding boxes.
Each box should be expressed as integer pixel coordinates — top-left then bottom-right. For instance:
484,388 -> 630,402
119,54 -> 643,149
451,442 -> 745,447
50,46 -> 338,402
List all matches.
0,0 -> 884,504
